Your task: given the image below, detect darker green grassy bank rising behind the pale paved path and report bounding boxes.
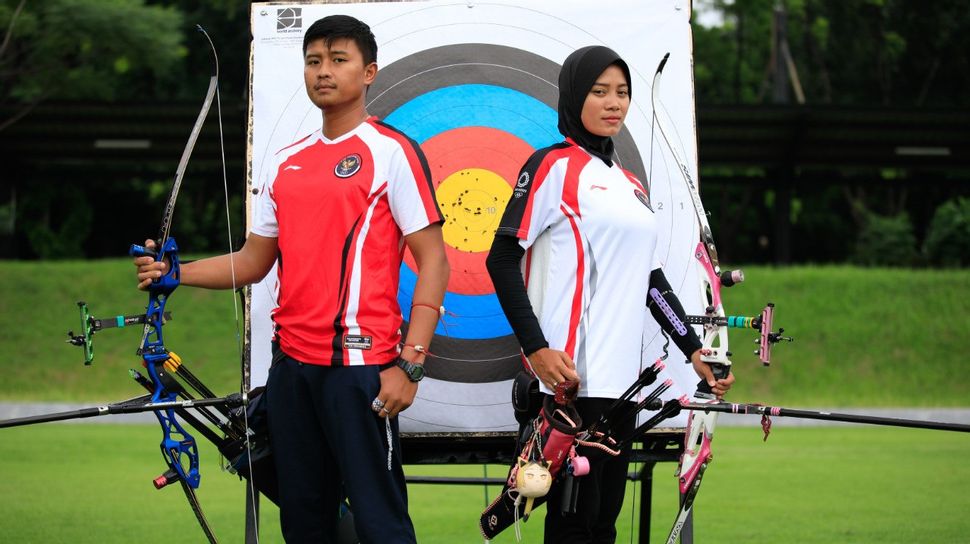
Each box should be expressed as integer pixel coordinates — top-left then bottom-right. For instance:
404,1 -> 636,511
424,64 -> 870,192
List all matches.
0,259 -> 970,406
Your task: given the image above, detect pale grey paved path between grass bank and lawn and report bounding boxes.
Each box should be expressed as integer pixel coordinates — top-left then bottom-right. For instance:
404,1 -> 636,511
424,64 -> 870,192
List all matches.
0,402 -> 970,427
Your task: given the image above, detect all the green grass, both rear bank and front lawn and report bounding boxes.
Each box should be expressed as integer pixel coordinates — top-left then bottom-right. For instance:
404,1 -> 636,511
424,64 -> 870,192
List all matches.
0,259 -> 970,544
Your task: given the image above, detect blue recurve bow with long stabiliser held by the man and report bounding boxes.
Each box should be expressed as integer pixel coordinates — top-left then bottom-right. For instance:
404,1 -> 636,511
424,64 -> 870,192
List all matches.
0,25 -> 260,542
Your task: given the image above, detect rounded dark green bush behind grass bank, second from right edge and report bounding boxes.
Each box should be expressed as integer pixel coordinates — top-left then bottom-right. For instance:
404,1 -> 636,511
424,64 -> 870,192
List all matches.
851,212 -> 918,267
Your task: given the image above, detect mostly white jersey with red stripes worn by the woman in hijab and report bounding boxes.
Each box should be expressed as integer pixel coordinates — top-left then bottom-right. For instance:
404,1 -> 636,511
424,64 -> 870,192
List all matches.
498,140 -> 660,398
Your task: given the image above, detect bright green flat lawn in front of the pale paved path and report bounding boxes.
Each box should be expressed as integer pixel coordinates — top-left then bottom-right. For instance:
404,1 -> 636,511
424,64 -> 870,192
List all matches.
0,424 -> 970,544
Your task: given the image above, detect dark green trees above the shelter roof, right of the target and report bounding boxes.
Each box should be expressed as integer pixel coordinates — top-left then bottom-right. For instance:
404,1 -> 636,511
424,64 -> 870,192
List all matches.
693,0 -> 970,107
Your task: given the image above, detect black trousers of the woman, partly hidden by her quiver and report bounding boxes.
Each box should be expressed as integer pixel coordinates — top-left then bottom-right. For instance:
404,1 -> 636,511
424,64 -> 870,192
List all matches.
544,398 -> 636,544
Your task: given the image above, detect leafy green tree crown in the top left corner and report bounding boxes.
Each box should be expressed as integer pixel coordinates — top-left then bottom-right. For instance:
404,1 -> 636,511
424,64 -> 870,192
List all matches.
0,0 -> 186,122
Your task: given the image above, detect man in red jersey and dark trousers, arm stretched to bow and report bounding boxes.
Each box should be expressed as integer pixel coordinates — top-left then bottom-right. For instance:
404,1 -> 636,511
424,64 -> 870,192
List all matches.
135,15 -> 449,544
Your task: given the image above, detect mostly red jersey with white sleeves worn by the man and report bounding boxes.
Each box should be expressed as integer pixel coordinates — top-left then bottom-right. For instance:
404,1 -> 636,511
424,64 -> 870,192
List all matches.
251,117 -> 442,365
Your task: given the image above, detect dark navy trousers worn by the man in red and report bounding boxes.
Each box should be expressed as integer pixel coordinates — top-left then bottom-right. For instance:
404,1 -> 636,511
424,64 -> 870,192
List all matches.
266,354 -> 415,544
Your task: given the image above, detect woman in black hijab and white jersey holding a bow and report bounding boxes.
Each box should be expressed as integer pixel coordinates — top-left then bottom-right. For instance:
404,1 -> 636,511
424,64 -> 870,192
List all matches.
486,46 -> 734,543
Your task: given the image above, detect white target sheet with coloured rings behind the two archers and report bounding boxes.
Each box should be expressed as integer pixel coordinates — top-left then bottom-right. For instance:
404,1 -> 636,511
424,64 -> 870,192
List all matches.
248,0 -> 701,433
